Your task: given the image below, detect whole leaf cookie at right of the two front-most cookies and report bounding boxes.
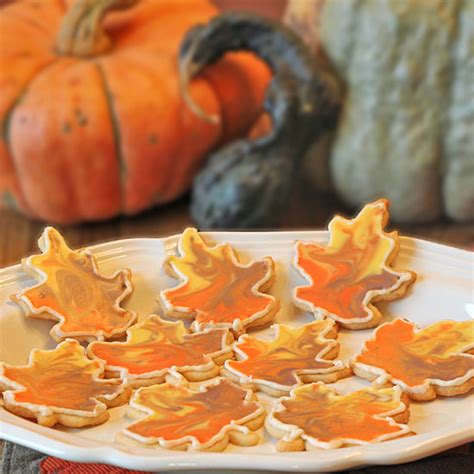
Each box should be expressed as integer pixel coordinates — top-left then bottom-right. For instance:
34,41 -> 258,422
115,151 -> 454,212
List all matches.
265,382 -> 410,451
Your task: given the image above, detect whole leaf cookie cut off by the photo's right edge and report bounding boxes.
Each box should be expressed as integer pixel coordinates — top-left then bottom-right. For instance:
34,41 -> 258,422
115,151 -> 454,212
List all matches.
352,319 -> 474,400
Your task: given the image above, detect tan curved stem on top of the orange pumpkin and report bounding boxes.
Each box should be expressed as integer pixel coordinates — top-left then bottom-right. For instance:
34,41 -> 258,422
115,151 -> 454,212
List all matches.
56,0 -> 137,57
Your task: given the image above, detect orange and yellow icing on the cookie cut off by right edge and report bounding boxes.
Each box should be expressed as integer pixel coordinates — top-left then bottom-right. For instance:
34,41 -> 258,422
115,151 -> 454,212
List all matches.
354,319 -> 474,387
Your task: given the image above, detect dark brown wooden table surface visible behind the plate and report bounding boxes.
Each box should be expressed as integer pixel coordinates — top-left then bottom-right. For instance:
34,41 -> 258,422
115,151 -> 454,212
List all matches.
0,186 -> 474,267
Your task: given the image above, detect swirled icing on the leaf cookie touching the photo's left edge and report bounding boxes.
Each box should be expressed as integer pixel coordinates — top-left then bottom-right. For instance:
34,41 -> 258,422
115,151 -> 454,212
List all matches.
0,339 -> 123,413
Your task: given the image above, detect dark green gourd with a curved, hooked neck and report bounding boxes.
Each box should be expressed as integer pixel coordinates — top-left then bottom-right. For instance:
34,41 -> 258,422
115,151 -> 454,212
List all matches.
180,12 -> 340,228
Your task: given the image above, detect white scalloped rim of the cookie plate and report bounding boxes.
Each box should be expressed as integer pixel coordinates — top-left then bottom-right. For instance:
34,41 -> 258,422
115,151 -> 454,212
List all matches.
0,230 -> 474,472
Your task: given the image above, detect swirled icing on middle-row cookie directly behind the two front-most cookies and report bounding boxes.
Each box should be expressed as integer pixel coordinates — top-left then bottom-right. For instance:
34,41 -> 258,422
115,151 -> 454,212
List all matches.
225,319 -> 343,389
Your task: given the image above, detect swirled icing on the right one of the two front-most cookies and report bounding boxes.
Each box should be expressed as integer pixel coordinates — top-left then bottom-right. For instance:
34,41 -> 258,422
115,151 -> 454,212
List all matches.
273,383 -> 408,444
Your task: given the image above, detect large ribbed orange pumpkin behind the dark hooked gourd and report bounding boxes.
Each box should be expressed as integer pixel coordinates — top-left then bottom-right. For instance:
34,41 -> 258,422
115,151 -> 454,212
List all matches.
0,0 -> 269,223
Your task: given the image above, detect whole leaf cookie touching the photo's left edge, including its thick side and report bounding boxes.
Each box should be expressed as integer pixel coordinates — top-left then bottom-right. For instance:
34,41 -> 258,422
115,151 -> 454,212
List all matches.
0,339 -> 131,428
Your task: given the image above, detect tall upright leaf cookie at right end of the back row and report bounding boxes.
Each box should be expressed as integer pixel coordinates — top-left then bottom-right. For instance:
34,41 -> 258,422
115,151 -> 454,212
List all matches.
293,199 -> 416,329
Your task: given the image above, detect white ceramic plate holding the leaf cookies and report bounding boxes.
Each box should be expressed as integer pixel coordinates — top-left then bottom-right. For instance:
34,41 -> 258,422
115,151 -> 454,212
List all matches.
0,232 -> 474,471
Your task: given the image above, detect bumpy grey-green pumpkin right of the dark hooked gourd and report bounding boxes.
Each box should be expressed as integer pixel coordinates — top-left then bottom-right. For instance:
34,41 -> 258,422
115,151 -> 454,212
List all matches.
285,0 -> 474,222
